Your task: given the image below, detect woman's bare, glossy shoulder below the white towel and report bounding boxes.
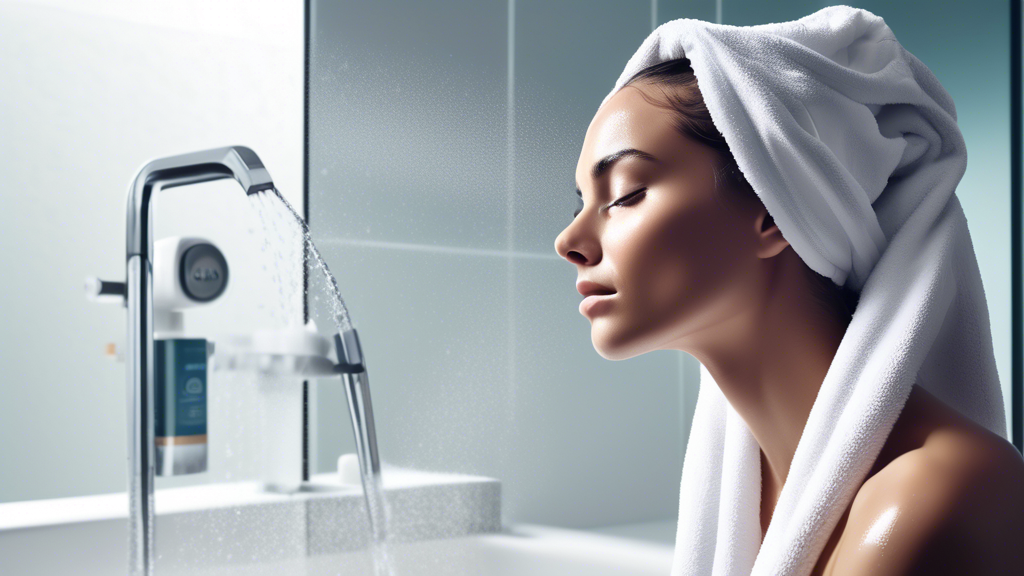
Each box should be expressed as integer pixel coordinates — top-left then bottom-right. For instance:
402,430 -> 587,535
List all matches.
831,407 -> 1024,576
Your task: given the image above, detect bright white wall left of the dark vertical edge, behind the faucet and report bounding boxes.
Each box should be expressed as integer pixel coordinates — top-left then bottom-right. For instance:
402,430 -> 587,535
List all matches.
0,0 -> 303,501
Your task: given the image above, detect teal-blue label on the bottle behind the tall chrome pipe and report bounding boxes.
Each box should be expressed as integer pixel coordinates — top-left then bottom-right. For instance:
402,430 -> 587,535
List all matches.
153,338 -> 207,438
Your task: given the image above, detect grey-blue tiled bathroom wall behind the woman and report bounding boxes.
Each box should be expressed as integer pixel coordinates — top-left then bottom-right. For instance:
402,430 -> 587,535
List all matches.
309,0 -> 1010,539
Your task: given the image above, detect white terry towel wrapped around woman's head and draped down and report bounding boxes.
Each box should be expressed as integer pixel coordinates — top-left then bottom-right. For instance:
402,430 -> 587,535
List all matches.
602,6 -> 1007,576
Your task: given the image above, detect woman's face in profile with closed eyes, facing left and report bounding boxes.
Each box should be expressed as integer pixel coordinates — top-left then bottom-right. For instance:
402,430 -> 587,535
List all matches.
555,81 -> 767,360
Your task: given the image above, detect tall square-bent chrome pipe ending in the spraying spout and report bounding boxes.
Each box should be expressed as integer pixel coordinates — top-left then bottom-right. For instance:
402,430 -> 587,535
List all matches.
125,146 -> 273,576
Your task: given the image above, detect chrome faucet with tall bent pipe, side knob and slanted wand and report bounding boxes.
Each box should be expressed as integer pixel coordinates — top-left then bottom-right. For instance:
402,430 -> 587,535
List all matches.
104,146 -> 386,576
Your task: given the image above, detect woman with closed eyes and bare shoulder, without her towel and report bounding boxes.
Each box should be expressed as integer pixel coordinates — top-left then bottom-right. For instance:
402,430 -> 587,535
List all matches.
555,47 -> 1024,576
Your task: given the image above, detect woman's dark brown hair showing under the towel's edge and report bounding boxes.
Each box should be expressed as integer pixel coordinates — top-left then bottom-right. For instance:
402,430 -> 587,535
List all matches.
623,58 -> 860,324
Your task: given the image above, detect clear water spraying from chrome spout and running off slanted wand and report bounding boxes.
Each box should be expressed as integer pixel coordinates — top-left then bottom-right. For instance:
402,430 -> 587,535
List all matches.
250,189 -> 394,576
